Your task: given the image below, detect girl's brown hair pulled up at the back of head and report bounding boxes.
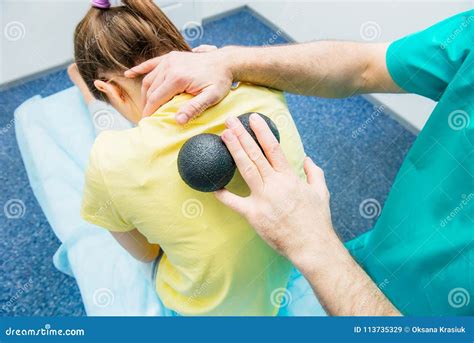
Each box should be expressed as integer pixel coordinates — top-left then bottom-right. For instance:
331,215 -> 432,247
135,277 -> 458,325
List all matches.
74,0 -> 190,101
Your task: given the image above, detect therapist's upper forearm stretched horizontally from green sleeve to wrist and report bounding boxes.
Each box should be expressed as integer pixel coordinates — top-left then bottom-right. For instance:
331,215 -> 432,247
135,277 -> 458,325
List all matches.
221,41 -> 401,98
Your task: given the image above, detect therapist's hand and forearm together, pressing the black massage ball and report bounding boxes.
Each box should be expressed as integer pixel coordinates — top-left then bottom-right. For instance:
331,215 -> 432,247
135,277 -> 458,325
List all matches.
216,114 -> 400,316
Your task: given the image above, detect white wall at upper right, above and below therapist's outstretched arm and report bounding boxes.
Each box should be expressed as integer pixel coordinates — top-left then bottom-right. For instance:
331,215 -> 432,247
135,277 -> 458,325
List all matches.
246,0 -> 473,132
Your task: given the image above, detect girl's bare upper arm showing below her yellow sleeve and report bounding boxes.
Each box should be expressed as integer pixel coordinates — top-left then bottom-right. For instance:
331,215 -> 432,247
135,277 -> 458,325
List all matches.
110,229 -> 160,262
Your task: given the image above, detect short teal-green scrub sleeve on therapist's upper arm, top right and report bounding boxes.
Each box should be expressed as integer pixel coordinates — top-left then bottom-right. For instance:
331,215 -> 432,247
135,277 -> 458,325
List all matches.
386,10 -> 474,101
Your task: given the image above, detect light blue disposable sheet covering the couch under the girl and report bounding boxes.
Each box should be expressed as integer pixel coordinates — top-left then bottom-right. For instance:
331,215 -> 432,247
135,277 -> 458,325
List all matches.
15,87 -> 325,316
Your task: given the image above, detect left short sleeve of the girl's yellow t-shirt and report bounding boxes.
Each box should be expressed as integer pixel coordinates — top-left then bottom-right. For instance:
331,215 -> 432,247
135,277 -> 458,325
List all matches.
81,143 -> 134,232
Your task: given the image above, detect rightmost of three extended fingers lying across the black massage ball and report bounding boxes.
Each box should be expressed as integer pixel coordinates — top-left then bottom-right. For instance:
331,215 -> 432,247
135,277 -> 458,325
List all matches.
250,113 -> 289,171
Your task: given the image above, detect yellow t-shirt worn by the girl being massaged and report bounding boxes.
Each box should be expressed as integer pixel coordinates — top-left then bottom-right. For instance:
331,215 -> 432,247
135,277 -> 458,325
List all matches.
81,84 -> 305,316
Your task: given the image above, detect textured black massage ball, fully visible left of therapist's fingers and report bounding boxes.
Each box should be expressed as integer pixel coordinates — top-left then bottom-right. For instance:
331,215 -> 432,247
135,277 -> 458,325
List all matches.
178,133 -> 236,192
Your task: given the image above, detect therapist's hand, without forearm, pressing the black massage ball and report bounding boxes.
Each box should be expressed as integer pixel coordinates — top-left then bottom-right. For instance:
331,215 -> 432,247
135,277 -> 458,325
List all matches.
215,114 -> 337,262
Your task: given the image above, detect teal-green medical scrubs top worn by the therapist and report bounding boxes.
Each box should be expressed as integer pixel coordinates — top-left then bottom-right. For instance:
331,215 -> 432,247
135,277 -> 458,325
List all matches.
347,10 -> 474,315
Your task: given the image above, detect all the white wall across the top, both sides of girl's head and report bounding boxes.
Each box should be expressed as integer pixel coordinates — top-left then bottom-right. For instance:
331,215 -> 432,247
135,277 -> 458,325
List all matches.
0,0 -> 474,131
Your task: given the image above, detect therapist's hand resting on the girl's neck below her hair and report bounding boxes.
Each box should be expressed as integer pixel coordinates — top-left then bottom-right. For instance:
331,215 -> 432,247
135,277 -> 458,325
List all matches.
125,45 -> 233,124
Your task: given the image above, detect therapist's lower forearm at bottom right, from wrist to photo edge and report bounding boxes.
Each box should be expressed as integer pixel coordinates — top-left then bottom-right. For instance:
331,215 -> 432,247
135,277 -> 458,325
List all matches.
290,228 -> 401,316
